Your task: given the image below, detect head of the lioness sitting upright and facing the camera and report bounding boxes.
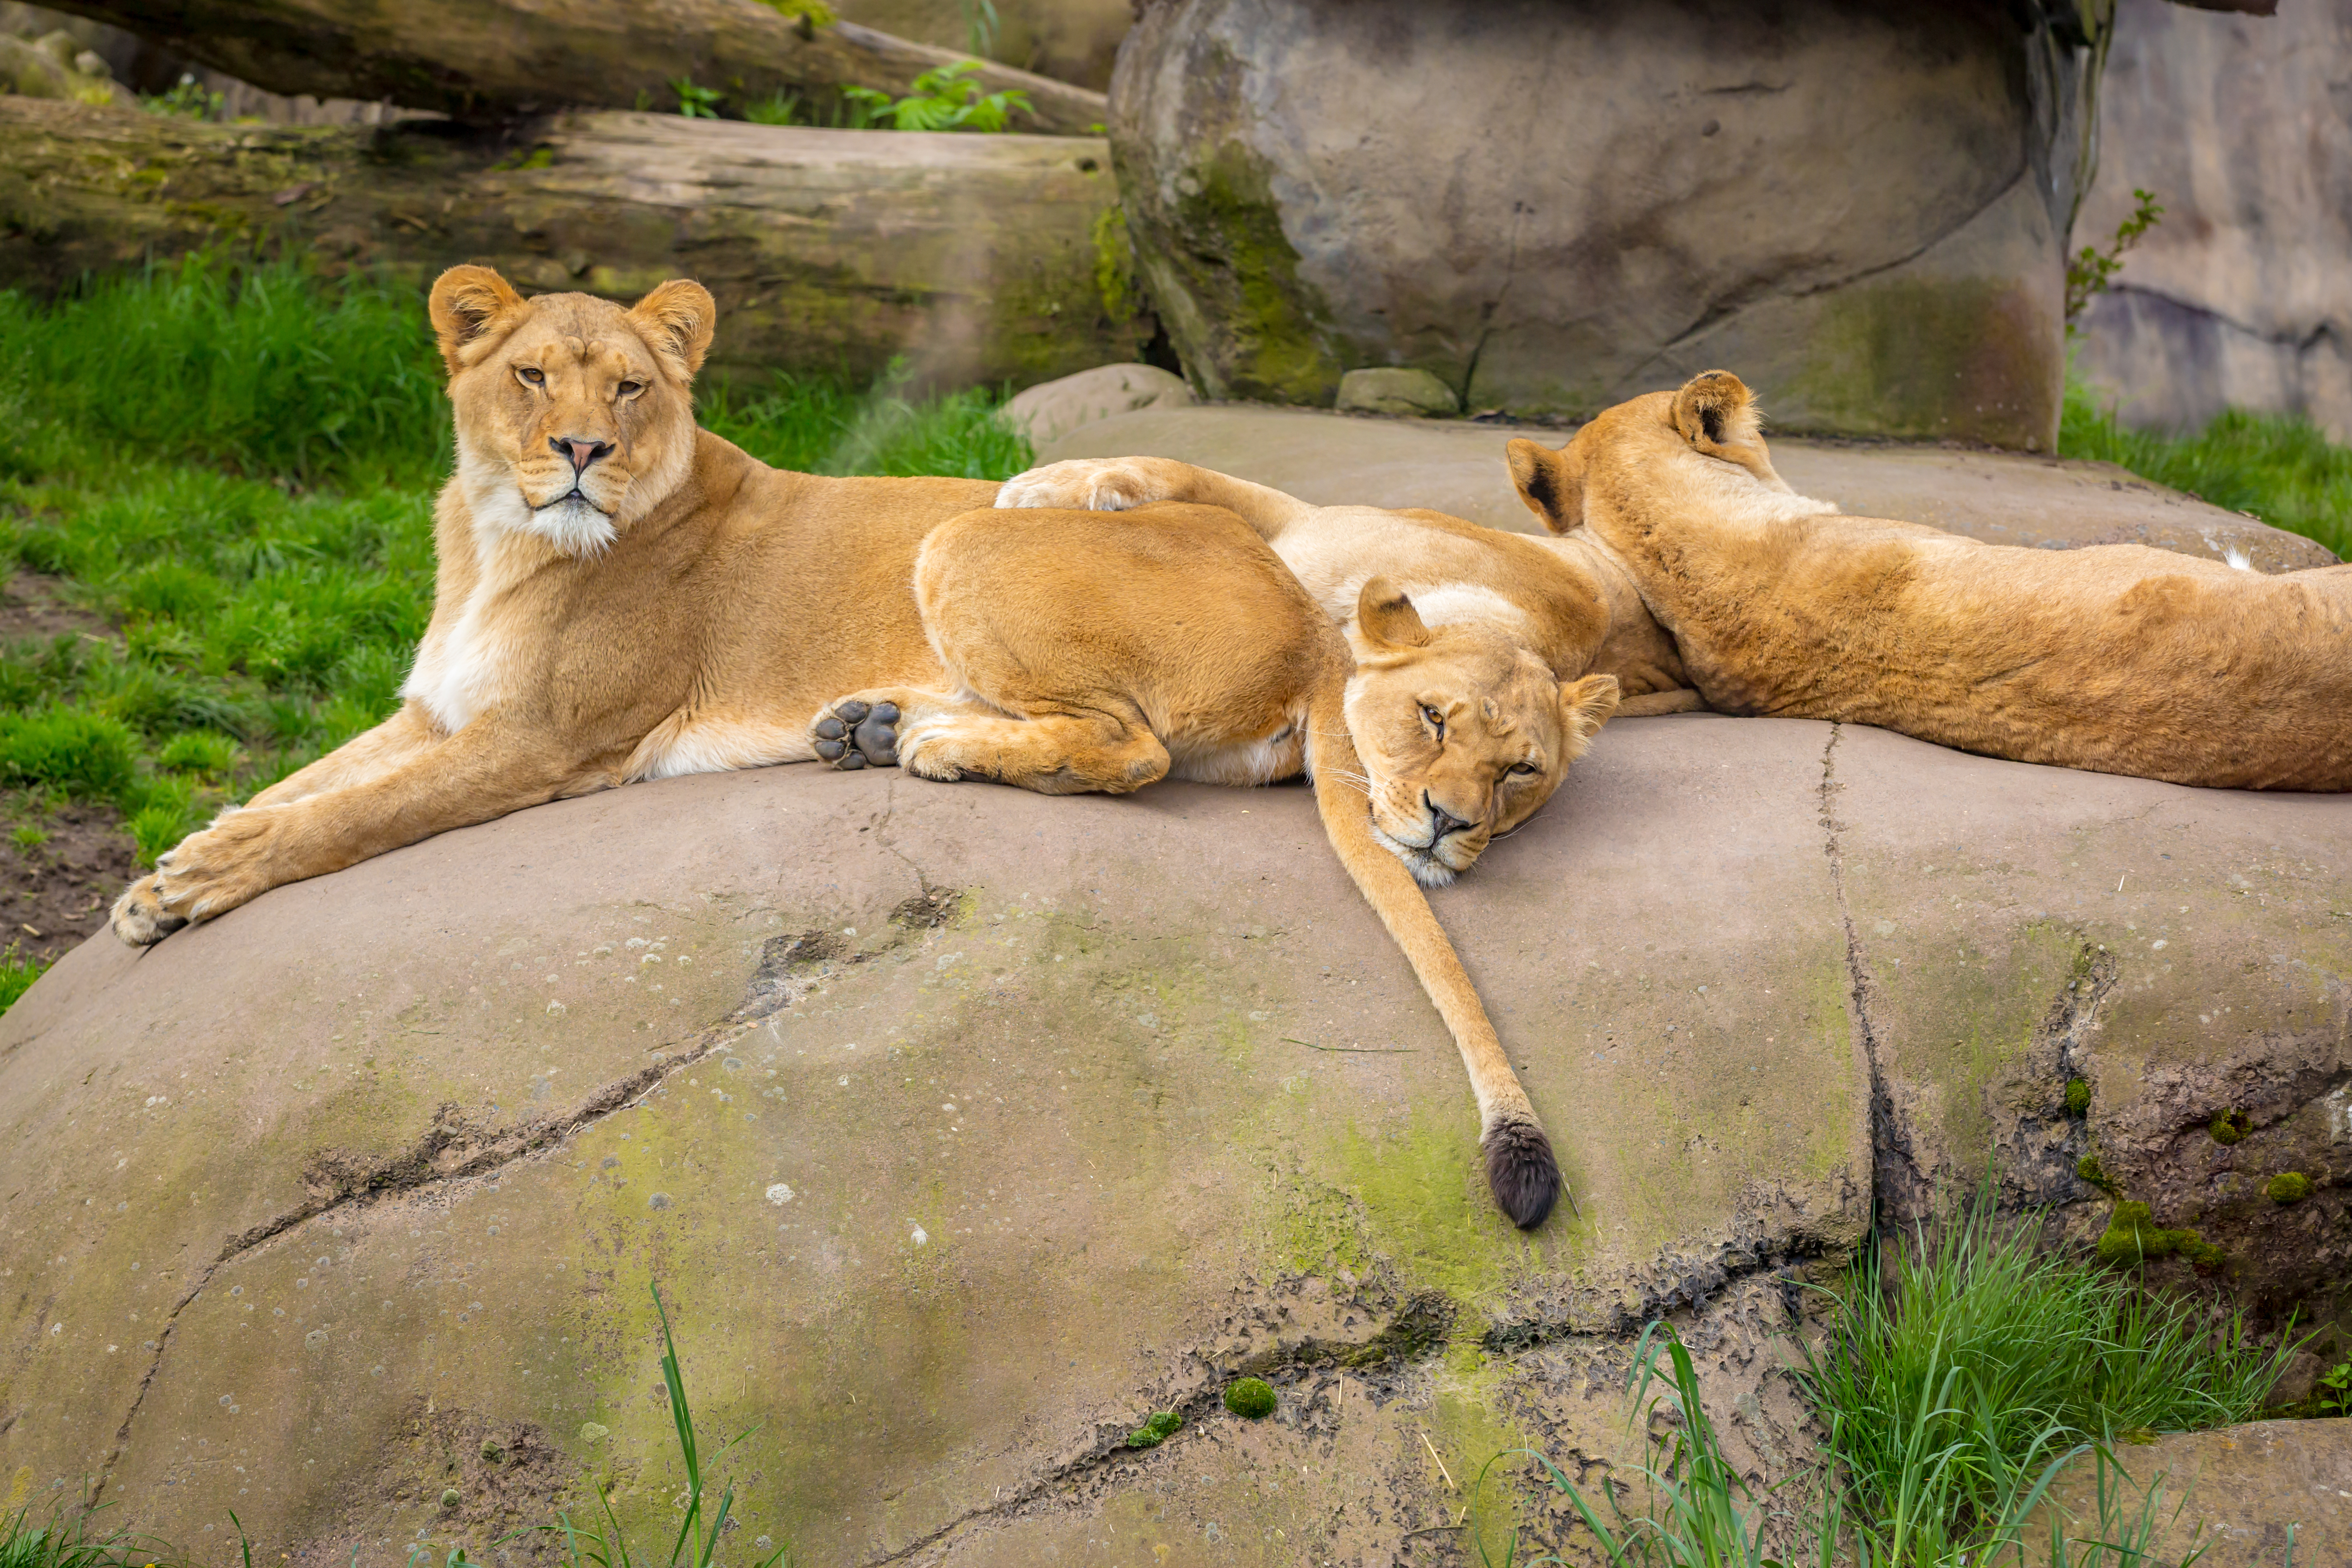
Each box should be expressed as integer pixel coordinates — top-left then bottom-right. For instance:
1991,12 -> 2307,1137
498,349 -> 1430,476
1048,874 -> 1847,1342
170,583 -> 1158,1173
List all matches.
430,266 -> 715,555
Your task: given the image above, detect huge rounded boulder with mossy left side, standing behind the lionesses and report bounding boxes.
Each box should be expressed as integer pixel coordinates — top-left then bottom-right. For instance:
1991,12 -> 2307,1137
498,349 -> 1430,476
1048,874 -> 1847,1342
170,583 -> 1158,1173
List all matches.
1110,0 -> 2110,451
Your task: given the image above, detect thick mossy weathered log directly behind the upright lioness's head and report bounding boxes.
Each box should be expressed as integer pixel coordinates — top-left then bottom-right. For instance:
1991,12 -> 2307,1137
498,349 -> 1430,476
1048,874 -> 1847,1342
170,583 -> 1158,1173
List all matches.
0,99 -> 1143,385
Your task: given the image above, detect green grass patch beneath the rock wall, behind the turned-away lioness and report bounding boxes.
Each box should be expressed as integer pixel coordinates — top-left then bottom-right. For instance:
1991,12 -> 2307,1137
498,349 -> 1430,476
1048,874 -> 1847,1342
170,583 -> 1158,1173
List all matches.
2058,381 -> 2352,555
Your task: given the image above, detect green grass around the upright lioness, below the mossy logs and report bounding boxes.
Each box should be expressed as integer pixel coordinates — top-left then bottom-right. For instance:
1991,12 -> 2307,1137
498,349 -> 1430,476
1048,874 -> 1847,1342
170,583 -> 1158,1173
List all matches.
0,245 -> 1030,1006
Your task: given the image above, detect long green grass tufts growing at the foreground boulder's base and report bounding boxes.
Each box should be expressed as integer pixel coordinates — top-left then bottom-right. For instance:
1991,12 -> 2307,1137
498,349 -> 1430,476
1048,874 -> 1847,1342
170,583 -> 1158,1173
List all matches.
1477,1215 -> 2296,1568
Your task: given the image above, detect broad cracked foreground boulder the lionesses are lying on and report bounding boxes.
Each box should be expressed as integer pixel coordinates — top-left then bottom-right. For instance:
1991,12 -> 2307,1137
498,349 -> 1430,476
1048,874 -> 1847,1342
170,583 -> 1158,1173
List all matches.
0,715 -> 2352,1568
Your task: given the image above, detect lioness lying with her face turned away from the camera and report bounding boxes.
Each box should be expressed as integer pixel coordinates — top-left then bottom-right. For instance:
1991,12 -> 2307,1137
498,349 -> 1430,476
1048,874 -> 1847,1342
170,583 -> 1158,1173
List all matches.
1510,372 -> 2352,790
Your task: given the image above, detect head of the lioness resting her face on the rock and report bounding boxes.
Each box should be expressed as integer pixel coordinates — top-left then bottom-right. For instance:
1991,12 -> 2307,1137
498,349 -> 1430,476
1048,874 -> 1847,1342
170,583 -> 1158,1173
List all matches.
1348,578 -> 1618,886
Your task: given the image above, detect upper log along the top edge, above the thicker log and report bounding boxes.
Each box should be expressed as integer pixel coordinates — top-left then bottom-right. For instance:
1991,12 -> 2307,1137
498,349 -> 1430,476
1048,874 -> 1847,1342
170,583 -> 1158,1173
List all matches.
30,0 -> 1108,134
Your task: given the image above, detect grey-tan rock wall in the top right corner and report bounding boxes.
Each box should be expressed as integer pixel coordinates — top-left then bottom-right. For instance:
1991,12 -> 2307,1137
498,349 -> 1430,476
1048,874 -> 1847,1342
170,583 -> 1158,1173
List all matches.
2074,0 -> 2352,442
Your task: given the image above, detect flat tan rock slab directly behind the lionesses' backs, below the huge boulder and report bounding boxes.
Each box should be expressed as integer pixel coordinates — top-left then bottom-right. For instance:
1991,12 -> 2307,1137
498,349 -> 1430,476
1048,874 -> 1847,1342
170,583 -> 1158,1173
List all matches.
1025,395 -> 2336,571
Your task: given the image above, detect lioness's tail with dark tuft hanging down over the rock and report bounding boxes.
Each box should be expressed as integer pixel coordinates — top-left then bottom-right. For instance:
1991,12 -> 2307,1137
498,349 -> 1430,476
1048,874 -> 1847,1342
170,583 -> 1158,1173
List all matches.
1308,679 -> 1562,1229
